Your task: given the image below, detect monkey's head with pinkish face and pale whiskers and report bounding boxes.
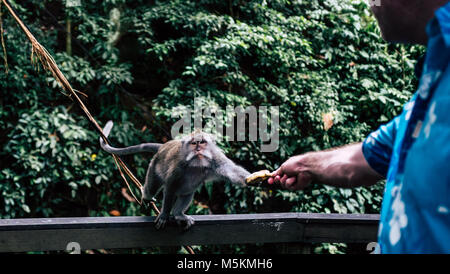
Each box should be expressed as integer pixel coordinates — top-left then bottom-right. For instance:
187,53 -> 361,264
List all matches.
182,132 -> 216,168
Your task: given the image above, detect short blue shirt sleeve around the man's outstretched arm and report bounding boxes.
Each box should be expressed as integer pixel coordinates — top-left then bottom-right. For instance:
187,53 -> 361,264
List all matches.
362,116 -> 400,177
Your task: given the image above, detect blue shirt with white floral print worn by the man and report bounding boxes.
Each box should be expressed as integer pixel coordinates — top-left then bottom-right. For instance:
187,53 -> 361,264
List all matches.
363,3 -> 450,253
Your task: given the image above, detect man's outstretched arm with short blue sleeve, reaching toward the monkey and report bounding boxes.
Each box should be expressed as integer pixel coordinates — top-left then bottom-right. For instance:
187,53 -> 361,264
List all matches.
268,109 -> 402,190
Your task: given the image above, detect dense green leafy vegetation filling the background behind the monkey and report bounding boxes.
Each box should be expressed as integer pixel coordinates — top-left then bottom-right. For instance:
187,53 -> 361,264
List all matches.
0,0 -> 423,253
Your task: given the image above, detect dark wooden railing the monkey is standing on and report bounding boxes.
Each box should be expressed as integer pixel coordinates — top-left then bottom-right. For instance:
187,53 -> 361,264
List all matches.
0,213 -> 379,252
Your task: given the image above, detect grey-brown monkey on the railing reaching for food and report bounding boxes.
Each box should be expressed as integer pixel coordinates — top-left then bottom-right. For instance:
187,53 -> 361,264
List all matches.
100,121 -> 250,230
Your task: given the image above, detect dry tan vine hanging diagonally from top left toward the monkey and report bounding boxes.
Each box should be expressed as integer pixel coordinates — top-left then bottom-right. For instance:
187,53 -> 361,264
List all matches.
0,0 -> 194,254
